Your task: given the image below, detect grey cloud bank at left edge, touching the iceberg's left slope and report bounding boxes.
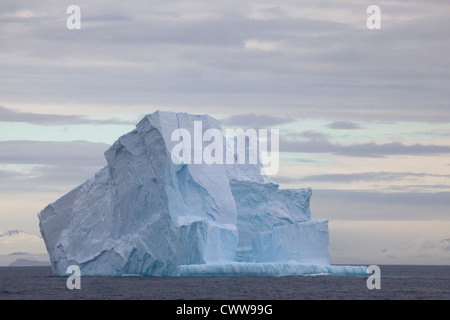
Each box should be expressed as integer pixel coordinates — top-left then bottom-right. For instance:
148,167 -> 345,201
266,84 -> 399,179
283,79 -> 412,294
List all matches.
0,140 -> 109,193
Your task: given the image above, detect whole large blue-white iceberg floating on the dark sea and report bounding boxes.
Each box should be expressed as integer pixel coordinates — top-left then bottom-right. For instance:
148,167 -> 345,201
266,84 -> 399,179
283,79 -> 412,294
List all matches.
38,111 -> 367,276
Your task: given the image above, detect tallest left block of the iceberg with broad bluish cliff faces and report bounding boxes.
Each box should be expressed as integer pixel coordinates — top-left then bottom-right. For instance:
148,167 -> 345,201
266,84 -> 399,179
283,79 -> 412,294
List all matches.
39,112 -> 237,275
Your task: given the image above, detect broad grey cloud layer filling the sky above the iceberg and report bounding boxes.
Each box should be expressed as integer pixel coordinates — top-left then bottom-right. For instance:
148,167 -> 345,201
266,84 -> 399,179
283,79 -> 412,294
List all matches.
0,1 -> 450,122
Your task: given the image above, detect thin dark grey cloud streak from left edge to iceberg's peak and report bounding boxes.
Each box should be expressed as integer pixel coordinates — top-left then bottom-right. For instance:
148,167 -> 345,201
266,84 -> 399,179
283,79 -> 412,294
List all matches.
0,106 -> 134,126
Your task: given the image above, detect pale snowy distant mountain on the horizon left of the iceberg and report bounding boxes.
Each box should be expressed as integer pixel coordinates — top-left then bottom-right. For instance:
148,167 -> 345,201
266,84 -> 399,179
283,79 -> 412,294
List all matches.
0,230 -> 49,266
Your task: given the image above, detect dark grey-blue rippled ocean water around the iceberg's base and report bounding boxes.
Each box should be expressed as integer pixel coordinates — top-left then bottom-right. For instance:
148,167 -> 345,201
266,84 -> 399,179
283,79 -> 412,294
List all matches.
0,265 -> 450,300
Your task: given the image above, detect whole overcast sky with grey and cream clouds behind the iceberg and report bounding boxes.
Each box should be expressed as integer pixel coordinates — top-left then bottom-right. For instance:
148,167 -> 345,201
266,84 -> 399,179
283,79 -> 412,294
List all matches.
0,0 -> 450,264
